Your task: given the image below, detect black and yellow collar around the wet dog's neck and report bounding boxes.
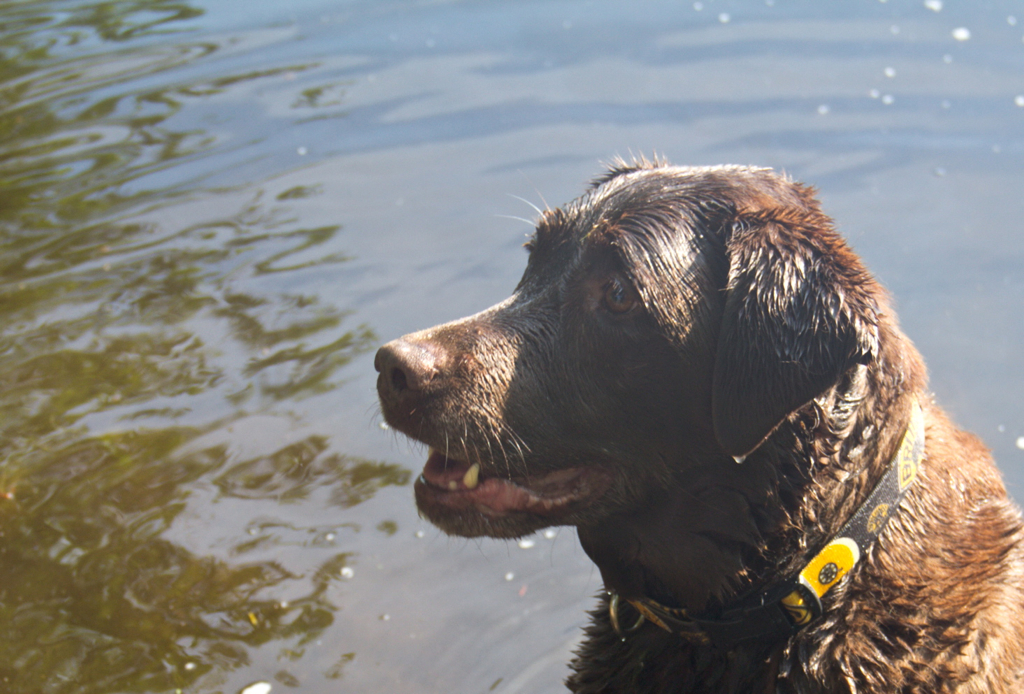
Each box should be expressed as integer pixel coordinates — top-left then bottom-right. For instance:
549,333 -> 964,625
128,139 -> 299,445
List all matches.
609,399 -> 925,650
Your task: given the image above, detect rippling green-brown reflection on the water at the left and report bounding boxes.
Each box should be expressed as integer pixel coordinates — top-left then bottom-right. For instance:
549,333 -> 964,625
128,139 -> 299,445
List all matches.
0,0 -> 399,693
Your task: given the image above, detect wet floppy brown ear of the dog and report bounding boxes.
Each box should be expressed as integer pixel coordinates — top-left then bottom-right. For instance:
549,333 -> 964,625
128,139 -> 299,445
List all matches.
712,203 -> 882,460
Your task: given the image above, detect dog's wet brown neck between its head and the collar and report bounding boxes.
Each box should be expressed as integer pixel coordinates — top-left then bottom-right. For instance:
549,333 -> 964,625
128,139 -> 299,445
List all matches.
580,331 -> 924,626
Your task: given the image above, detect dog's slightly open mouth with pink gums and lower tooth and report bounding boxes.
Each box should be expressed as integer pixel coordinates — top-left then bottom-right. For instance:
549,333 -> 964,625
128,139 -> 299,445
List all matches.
416,448 -> 610,517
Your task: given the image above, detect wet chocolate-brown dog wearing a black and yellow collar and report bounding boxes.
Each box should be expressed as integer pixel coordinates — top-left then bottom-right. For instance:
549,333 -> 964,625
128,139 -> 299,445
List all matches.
376,162 -> 1024,694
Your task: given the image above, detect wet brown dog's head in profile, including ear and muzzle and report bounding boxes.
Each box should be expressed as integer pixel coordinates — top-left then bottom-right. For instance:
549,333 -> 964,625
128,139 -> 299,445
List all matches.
376,162 -> 879,537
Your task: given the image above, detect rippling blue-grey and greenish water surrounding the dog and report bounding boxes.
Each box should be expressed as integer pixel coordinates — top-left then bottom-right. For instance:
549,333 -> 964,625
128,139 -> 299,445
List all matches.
0,0 -> 1024,694
